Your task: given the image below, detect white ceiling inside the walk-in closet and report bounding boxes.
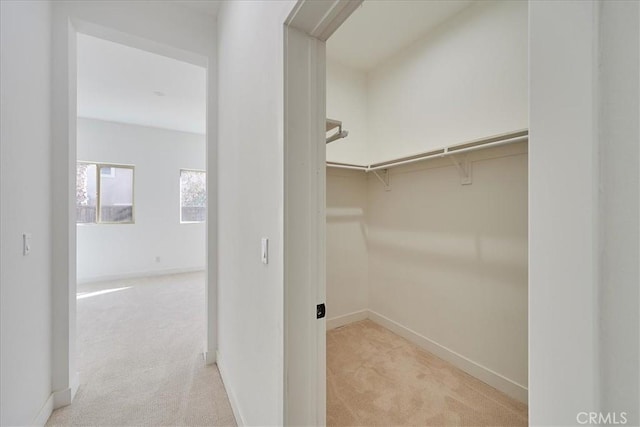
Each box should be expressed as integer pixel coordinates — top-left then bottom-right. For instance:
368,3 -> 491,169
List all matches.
327,0 -> 473,71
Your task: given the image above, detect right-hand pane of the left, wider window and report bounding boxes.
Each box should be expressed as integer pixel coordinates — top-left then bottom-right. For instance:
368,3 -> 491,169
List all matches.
100,166 -> 133,222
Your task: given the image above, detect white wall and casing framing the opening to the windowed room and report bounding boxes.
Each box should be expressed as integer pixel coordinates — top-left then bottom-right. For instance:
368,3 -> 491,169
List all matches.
52,0 -> 218,405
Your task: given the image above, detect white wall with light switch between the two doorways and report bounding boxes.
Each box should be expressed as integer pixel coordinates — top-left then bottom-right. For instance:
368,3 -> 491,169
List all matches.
218,1 -> 293,425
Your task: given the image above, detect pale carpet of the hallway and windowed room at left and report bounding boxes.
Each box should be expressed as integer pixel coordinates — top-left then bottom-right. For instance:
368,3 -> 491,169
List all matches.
47,273 -> 236,426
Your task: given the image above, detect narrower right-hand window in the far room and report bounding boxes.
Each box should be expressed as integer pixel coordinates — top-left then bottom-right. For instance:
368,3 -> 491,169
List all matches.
180,169 -> 207,222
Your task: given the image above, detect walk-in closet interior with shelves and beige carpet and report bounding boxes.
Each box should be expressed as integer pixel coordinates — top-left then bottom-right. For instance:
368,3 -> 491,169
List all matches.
326,1 -> 528,426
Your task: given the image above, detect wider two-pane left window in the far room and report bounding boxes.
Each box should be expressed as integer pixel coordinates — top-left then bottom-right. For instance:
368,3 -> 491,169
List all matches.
76,162 -> 134,224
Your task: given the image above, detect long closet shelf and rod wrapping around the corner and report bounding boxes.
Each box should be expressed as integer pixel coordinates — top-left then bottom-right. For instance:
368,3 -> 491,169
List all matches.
327,129 -> 529,172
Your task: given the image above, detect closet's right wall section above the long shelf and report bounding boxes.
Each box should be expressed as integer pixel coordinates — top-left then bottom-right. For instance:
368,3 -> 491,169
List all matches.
362,1 -> 528,163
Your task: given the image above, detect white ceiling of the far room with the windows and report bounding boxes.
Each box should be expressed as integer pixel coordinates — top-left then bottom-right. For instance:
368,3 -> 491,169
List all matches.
78,33 -> 206,134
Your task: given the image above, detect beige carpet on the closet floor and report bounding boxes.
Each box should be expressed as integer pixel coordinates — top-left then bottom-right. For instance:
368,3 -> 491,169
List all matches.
327,320 -> 528,426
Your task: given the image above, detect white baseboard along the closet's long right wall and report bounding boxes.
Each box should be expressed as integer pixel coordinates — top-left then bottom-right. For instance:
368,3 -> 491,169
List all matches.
368,310 -> 529,403
